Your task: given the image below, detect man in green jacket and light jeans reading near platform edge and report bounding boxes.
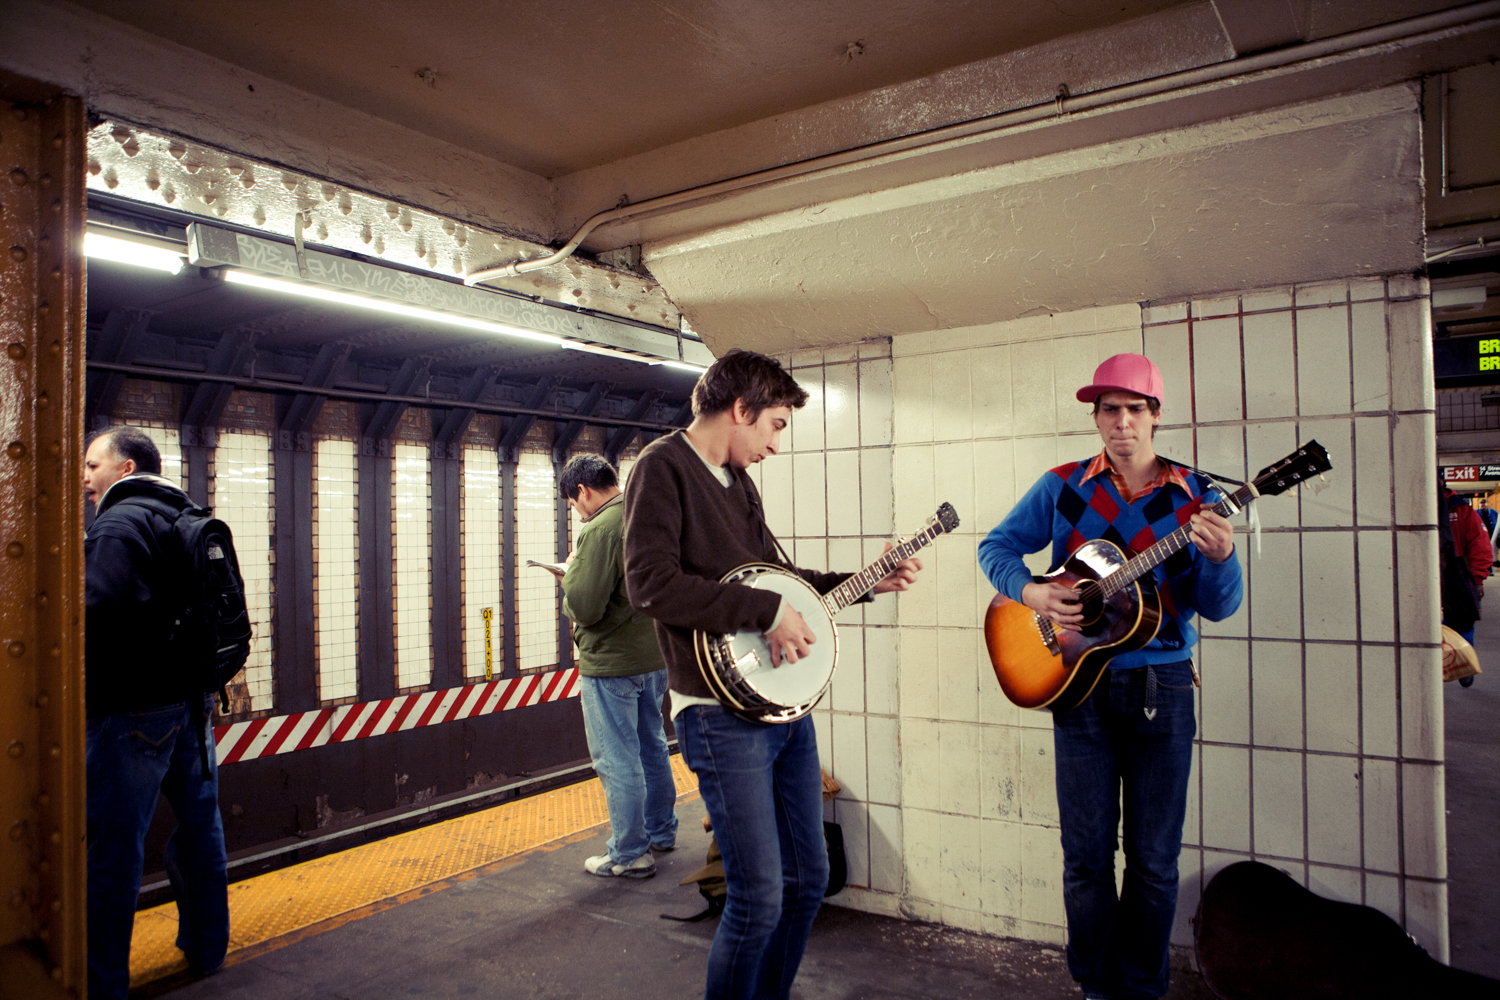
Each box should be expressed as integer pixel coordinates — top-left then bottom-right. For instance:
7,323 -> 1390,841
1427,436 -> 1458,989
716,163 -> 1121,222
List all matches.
558,454 -> 677,879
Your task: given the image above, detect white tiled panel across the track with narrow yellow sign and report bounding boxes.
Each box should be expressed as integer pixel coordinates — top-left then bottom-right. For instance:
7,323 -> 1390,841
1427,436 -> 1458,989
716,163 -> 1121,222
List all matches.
462,448 -> 506,678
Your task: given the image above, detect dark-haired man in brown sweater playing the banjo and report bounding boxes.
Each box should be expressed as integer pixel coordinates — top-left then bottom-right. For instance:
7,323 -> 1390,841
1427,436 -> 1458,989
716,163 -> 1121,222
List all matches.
626,351 -> 921,1000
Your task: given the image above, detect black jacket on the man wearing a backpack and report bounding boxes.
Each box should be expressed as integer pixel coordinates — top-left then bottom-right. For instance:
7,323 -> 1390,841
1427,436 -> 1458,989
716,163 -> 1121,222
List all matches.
84,475 -> 203,718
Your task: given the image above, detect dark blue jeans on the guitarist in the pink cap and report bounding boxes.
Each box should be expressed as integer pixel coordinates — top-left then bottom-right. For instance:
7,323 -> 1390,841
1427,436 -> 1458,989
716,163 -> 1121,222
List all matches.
1053,660 -> 1197,997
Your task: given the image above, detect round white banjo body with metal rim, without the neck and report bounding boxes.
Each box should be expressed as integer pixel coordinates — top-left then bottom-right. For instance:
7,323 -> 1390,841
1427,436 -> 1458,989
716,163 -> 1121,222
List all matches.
710,564 -> 839,723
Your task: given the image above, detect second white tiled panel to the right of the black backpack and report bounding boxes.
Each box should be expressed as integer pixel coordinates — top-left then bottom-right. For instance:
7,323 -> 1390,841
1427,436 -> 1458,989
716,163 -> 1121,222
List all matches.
312,438 -> 360,702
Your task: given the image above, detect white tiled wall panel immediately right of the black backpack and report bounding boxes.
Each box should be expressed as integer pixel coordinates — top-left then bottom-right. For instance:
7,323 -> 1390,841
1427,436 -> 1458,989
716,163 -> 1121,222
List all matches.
213,432 -> 276,712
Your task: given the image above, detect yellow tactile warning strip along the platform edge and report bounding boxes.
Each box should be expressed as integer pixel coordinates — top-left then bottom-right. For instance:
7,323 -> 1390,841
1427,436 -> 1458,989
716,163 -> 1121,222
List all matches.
131,756 -> 698,987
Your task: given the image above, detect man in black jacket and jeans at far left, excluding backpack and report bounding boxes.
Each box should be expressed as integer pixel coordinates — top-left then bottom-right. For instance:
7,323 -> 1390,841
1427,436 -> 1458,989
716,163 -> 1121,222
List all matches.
84,427 -> 230,1000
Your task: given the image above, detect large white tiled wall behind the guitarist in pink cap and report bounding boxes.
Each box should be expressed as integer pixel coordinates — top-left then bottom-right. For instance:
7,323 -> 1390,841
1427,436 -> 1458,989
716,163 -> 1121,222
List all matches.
792,277 -> 1448,955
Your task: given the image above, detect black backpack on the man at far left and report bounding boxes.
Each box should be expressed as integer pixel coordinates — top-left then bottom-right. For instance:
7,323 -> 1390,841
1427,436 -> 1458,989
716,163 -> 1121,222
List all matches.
120,496 -> 252,712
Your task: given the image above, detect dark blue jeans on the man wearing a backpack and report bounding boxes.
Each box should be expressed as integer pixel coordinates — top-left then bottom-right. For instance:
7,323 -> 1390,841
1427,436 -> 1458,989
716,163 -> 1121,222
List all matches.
86,696 -> 230,1000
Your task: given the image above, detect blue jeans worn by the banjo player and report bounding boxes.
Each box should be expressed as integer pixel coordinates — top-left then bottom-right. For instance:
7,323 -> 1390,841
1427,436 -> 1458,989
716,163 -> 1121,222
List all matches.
677,705 -> 828,1000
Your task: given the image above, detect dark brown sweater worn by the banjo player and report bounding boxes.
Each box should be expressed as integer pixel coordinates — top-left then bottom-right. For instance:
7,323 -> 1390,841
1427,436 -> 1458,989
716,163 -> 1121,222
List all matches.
626,430 -> 849,697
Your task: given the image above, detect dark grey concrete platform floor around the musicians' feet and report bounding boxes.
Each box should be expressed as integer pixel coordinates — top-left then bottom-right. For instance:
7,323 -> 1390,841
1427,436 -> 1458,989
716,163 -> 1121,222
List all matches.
150,799 -> 1212,1000
